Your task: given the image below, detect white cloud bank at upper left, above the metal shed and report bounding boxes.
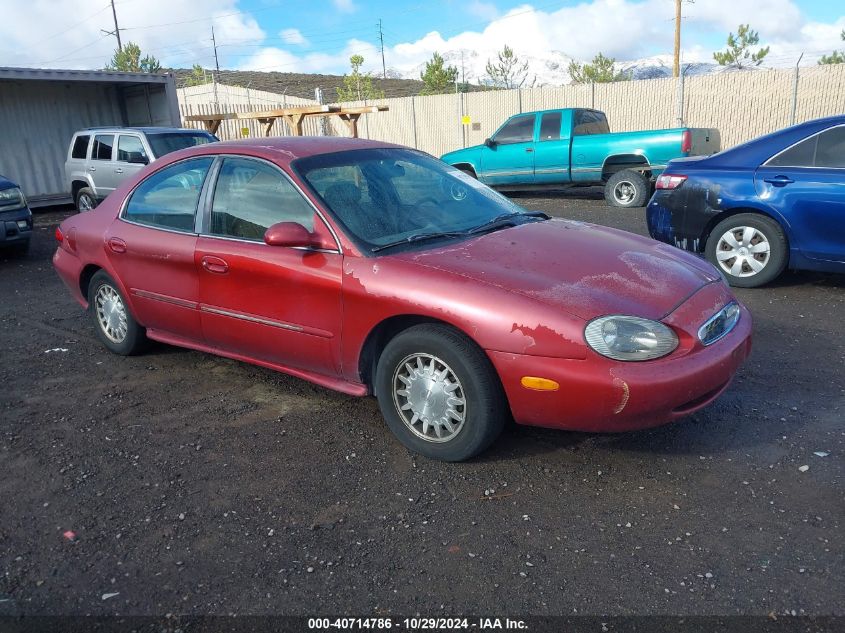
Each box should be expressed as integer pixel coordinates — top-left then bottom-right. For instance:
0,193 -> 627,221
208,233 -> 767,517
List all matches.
0,0 -> 265,68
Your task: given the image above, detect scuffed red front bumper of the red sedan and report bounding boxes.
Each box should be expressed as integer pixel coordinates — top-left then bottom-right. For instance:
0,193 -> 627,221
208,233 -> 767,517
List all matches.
488,284 -> 751,432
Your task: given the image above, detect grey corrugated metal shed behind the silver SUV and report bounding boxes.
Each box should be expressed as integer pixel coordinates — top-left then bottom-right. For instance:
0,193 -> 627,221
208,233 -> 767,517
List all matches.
0,80 -> 171,199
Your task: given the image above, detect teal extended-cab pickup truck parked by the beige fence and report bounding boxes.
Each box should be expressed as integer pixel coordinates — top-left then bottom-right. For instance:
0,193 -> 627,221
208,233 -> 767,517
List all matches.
441,108 -> 719,207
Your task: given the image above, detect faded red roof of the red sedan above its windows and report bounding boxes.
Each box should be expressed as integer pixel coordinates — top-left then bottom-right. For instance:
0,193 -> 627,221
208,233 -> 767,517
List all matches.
161,136 -> 408,163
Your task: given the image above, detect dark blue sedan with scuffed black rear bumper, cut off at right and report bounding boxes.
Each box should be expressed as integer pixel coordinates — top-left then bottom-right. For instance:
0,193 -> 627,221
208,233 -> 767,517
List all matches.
646,115 -> 845,288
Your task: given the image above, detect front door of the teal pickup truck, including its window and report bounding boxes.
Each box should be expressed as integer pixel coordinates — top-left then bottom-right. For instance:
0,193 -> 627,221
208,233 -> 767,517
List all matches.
479,112 -> 537,185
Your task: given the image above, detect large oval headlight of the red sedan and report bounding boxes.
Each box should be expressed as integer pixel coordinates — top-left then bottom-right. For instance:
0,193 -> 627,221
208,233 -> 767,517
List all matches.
584,315 -> 678,361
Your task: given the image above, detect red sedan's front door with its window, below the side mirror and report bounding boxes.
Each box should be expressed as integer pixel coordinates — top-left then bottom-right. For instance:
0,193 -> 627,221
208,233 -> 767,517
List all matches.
196,157 -> 343,374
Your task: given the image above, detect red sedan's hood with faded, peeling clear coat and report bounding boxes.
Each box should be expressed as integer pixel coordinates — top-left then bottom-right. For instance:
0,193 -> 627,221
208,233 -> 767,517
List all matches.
393,219 -> 720,320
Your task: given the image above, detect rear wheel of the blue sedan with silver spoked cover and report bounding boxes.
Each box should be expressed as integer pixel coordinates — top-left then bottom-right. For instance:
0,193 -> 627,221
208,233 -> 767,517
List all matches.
704,213 -> 789,288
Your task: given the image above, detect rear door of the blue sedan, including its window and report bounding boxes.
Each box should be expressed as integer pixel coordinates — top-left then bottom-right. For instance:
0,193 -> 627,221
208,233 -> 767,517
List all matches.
754,125 -> 845,262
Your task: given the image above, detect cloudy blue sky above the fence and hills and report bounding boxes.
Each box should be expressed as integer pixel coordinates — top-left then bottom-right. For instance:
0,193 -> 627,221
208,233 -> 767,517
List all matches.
0,0 -> 845,74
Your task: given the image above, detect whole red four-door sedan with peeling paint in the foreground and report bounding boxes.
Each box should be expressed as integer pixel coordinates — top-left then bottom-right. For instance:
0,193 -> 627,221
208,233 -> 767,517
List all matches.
53,137 -> 751,461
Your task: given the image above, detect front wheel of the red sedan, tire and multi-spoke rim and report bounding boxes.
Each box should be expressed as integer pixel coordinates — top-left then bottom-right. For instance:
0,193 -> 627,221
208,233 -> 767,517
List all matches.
375,324 -> 510,462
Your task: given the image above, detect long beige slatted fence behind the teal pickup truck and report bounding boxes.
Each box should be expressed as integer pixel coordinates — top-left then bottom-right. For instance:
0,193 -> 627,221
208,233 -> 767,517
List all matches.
180,64 -> 845,156
